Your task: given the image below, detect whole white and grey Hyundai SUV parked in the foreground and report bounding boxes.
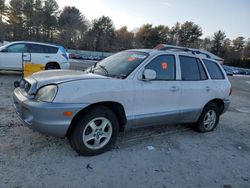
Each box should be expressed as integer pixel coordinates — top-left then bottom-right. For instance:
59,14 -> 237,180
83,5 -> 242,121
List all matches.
14,45 -> 231,155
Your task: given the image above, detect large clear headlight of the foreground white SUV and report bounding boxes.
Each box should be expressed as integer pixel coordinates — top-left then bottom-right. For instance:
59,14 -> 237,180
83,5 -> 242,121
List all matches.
35,85 -> 57,102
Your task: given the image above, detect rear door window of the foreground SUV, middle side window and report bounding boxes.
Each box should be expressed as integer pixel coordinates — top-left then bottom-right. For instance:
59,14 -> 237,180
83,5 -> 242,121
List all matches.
180,56 -> 208,81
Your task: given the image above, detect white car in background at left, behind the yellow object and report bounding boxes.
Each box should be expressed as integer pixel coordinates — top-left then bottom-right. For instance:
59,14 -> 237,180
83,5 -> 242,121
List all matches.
0,41 -> 69,70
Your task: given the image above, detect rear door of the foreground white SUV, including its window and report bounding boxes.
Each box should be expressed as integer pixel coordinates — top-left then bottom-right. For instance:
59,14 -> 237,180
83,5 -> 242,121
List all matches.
179,55 -> 213,122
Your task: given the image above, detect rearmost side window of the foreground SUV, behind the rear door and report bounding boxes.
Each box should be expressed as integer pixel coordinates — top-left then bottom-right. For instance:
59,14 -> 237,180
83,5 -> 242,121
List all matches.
203,59 -> 225,80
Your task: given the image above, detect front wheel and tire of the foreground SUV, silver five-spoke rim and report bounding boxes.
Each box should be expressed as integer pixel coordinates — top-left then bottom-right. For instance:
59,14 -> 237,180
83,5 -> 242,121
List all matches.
69,106 -> 119,156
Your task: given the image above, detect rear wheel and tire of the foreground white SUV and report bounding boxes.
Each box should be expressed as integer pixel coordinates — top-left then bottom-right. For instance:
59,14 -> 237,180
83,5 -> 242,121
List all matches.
196,103 -> 220,133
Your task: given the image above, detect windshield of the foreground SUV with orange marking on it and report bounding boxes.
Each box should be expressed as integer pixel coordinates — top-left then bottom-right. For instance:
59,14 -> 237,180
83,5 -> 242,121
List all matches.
89,51 -> 148,78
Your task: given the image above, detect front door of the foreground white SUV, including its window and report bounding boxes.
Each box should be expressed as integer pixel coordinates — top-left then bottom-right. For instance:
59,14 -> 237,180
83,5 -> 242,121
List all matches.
134,55 -> 180,126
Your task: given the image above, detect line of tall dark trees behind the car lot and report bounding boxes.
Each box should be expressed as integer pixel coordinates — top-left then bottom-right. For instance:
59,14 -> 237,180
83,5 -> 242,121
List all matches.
0,0 -> 250,68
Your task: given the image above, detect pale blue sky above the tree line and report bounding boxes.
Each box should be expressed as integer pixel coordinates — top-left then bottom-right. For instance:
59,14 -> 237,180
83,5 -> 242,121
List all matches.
57,0 -> 250,39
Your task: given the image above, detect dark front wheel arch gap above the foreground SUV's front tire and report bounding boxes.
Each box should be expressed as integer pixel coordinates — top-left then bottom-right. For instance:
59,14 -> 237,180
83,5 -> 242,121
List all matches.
66,101 -> 127,136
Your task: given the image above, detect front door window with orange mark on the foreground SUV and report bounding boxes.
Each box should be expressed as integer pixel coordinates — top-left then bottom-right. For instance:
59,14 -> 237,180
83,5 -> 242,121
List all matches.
146,55 -> 175,80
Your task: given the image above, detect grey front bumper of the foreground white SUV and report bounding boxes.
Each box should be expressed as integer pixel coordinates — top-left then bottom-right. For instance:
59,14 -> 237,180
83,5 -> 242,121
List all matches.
13,88 -> 88,137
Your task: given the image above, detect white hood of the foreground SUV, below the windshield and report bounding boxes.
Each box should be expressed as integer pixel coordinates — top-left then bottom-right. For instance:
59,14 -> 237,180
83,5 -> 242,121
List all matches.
25,70 -> 107,89
